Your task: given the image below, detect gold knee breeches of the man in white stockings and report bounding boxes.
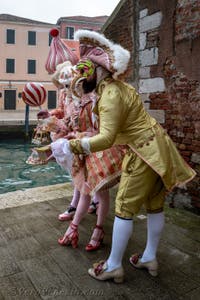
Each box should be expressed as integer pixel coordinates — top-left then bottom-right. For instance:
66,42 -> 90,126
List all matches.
115,150 -> 166,219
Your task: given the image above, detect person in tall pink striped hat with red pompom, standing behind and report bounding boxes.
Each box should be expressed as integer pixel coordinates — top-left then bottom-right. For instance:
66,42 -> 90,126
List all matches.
45,28 -> 98,221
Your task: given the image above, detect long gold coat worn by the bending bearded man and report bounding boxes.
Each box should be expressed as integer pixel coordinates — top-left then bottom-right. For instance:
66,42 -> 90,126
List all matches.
72,78 -> 196,190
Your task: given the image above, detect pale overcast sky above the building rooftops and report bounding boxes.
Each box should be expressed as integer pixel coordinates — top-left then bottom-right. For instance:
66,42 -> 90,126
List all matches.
0,0 -> 120,24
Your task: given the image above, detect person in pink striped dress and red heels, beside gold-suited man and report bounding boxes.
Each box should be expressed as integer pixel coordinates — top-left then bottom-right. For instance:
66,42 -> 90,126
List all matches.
51,72 -> 124,251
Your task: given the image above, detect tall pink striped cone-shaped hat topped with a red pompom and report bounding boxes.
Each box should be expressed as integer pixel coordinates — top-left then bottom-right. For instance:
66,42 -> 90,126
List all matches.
45,28 -> 79,74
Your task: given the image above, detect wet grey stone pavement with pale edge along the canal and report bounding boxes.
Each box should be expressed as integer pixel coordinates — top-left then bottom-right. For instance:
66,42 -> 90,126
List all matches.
0,184 -> 200,300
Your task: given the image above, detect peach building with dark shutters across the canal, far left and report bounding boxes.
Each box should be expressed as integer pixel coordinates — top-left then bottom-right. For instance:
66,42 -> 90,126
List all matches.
0,15 -> 56,112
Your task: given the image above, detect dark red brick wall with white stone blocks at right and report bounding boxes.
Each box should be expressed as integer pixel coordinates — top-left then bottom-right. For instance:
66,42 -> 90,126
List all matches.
104,0 -> 200,209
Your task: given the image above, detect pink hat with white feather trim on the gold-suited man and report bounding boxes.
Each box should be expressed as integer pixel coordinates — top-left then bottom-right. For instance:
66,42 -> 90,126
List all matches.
74,30 -> 130,78
